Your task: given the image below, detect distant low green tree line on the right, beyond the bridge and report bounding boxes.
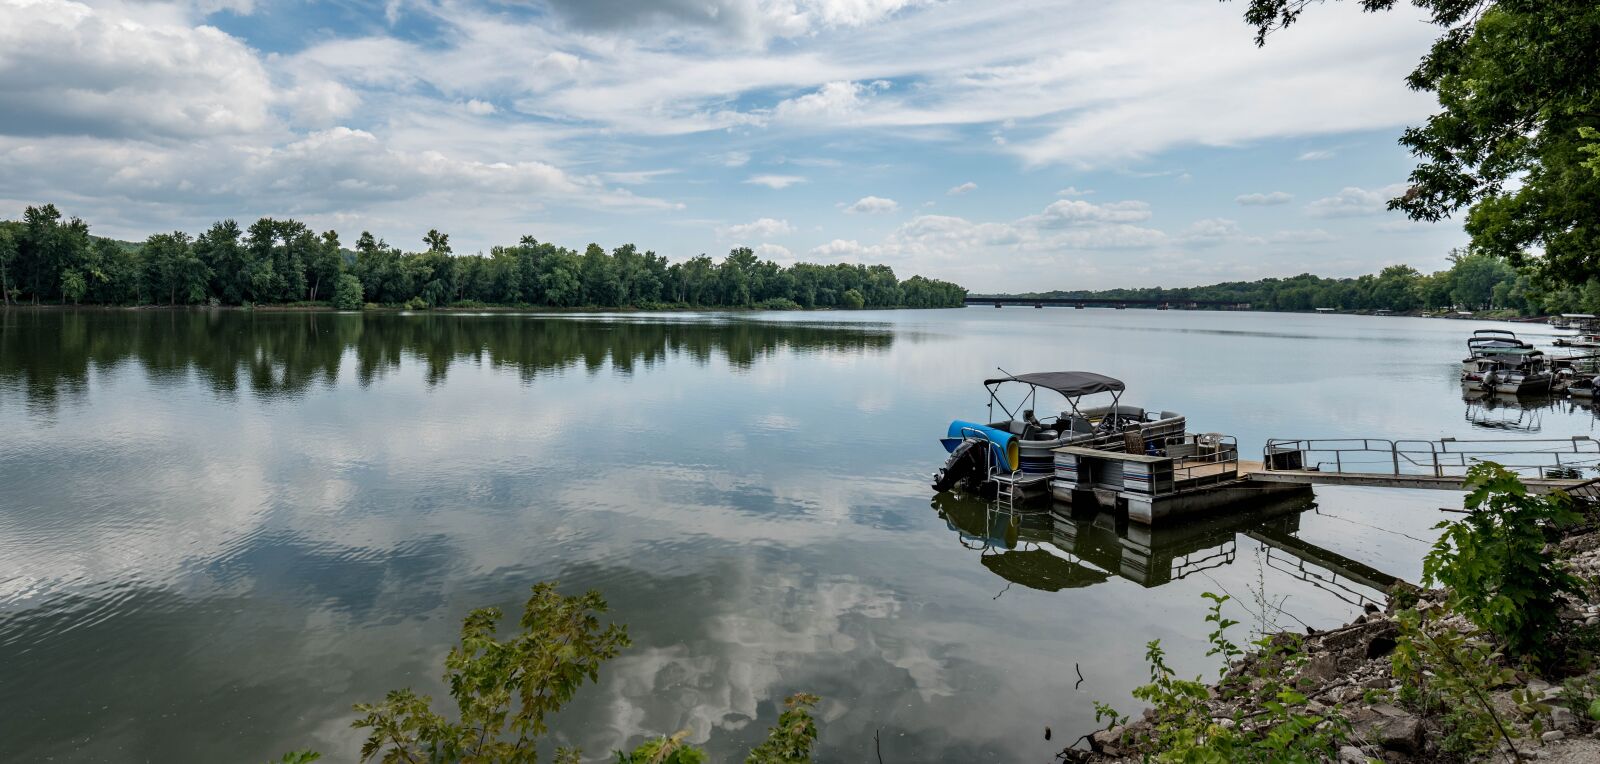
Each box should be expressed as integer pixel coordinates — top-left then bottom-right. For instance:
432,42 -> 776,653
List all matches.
1004,249 -> 1600,315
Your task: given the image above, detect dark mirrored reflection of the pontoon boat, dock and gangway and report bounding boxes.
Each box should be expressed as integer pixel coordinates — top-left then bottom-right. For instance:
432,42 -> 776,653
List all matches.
933,492 -> 1397,606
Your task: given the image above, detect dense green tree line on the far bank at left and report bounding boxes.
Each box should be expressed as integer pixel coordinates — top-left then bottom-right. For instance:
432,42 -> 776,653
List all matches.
0,205 -> 966,308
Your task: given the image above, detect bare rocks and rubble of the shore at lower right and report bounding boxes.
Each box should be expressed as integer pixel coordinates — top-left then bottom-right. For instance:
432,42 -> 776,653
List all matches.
1061,524 -> 1600,764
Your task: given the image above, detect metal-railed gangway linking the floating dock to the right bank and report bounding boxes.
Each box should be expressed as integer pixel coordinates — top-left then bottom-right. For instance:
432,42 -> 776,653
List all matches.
1262,435 -> 1600,478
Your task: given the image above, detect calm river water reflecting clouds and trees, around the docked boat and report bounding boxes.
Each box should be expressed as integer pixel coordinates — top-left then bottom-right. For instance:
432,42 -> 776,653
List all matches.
0,308 -> 1595,762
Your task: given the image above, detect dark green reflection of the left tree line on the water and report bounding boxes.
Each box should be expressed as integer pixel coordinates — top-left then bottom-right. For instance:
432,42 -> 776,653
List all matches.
0,310 -> 894,409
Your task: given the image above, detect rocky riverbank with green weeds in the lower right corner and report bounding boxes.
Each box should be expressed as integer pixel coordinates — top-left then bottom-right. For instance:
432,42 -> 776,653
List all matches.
1062,507 -> 1600,764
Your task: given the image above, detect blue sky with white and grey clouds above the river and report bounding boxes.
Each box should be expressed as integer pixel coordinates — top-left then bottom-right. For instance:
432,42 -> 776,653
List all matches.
0,0 -> 1466,291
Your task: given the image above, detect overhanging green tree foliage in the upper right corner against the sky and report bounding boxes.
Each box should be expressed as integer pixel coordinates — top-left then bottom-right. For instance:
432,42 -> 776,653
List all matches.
1245,0 -> 1600,283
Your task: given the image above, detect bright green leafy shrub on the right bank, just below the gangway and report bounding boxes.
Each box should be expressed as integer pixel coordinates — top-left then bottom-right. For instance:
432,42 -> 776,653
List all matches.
1422,462 -> 1581,662
